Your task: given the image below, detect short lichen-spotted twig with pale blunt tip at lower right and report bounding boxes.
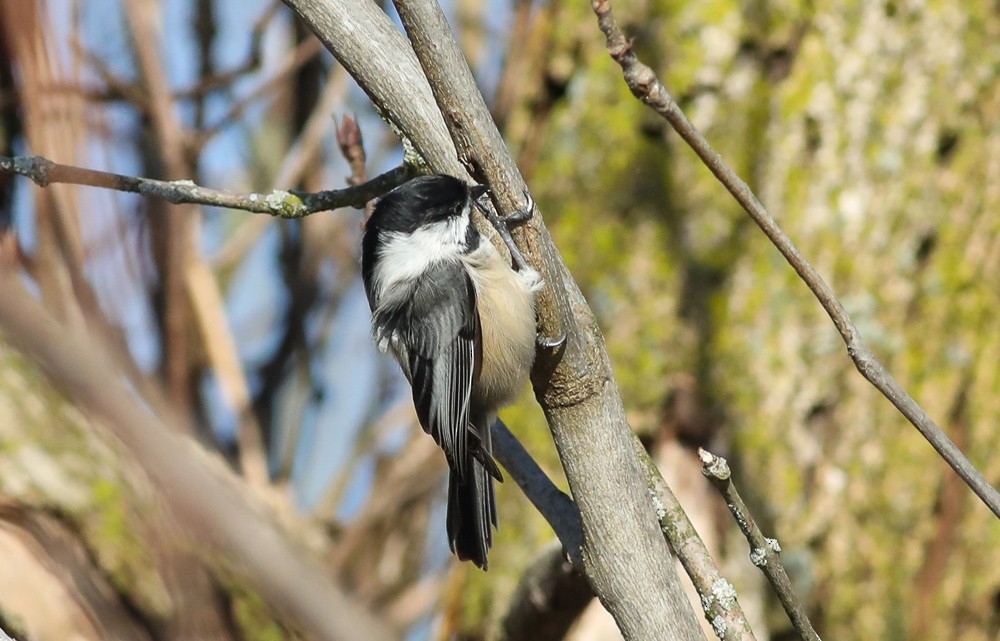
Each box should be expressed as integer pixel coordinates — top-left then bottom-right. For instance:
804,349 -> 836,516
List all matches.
698,448 -> 820,641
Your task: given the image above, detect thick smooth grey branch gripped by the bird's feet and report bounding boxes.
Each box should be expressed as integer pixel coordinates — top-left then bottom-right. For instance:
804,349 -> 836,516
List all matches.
395,0 -> 703,641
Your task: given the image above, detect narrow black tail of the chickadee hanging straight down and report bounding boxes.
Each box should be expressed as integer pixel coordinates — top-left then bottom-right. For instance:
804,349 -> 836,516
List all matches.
448,455 -> 497,570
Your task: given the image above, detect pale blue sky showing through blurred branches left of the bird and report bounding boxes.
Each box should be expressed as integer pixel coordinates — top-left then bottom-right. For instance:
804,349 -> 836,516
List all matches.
49,0 -> 510,536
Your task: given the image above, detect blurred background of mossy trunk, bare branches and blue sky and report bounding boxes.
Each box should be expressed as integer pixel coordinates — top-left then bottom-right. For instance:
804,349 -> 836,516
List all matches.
0,0 -> 1000,641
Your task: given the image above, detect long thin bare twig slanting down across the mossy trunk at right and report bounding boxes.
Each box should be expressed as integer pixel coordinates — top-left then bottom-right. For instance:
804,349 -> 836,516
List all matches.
591,0 -> 1000,517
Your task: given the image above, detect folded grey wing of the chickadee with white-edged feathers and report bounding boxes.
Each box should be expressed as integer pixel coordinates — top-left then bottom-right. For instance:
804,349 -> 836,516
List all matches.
374,262 -> 484,481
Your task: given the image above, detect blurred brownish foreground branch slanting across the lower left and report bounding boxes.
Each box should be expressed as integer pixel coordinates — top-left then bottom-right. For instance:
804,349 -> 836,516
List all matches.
0,271 -> 396,641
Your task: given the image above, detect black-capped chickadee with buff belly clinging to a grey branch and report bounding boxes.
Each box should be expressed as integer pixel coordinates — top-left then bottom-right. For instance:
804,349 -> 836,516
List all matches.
361,175 -> 543,570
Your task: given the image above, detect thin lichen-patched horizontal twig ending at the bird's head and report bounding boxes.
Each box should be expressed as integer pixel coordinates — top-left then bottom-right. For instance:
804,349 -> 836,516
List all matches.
0,156 -> 413,218
